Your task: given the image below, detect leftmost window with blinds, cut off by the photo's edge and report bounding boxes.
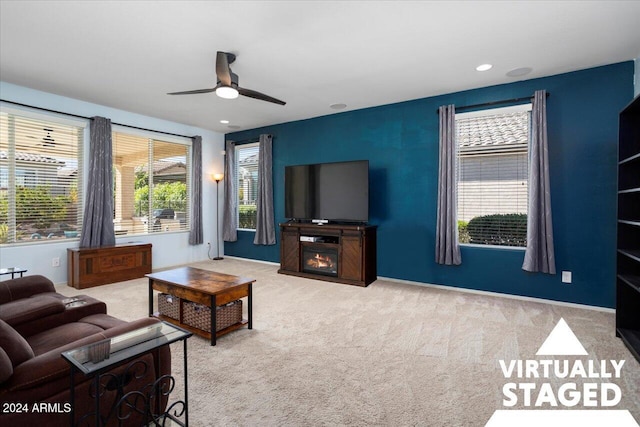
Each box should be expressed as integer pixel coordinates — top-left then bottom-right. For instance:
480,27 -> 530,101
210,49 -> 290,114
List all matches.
0,109 -> 86,245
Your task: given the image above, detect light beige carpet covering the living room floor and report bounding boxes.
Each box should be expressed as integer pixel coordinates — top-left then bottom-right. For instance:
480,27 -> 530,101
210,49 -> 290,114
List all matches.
59,259 -> 640,426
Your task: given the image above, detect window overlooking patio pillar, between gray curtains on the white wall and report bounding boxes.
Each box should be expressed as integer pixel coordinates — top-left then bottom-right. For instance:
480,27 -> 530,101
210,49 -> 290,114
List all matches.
113,127 -> 191,235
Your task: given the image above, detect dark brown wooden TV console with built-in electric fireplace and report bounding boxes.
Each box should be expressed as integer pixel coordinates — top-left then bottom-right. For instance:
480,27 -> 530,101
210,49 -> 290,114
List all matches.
278,222 -> 378,286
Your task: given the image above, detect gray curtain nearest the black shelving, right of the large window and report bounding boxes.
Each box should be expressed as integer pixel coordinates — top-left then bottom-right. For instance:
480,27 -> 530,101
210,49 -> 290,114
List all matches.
522,90 -> 556,274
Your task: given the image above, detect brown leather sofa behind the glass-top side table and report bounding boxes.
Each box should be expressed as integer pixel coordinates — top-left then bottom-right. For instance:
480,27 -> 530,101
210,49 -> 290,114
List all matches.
0,276 -> 171,426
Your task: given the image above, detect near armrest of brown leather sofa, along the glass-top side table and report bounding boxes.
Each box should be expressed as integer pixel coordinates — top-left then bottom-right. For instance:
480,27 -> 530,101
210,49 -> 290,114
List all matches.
6,317 -> 159,392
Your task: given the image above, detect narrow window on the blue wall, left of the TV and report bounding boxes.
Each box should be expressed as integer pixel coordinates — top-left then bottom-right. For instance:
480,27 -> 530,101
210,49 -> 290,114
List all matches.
235,143 -> 260,230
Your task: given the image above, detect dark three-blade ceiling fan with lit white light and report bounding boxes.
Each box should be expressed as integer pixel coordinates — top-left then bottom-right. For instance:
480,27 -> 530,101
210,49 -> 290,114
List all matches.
167,51 -> 286,105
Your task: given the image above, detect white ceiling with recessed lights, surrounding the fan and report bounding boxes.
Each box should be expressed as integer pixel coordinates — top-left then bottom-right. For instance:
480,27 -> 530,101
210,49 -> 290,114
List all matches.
0,0 -> 640,133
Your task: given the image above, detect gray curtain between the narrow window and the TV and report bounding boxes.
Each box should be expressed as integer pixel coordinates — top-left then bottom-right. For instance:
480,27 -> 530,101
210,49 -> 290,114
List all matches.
253,134 -> 276,245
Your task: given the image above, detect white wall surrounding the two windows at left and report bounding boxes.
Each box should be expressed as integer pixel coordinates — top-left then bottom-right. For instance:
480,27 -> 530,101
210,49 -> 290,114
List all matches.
0,81 -> 224,284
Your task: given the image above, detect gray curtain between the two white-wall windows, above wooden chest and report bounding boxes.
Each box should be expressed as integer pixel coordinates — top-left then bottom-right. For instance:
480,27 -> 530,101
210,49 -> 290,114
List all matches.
80,117 -> 116,248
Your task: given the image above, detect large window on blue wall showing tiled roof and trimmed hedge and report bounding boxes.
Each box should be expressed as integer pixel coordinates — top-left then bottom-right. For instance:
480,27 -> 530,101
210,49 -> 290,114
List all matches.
456,104 -> 531,247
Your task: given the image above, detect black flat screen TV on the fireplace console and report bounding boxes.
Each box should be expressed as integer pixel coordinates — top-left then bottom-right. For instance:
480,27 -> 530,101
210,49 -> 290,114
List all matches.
284,160 -> 369,222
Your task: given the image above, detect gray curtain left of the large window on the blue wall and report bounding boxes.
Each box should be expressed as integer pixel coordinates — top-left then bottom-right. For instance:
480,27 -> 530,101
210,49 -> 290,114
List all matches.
436,105 -> 462,265
